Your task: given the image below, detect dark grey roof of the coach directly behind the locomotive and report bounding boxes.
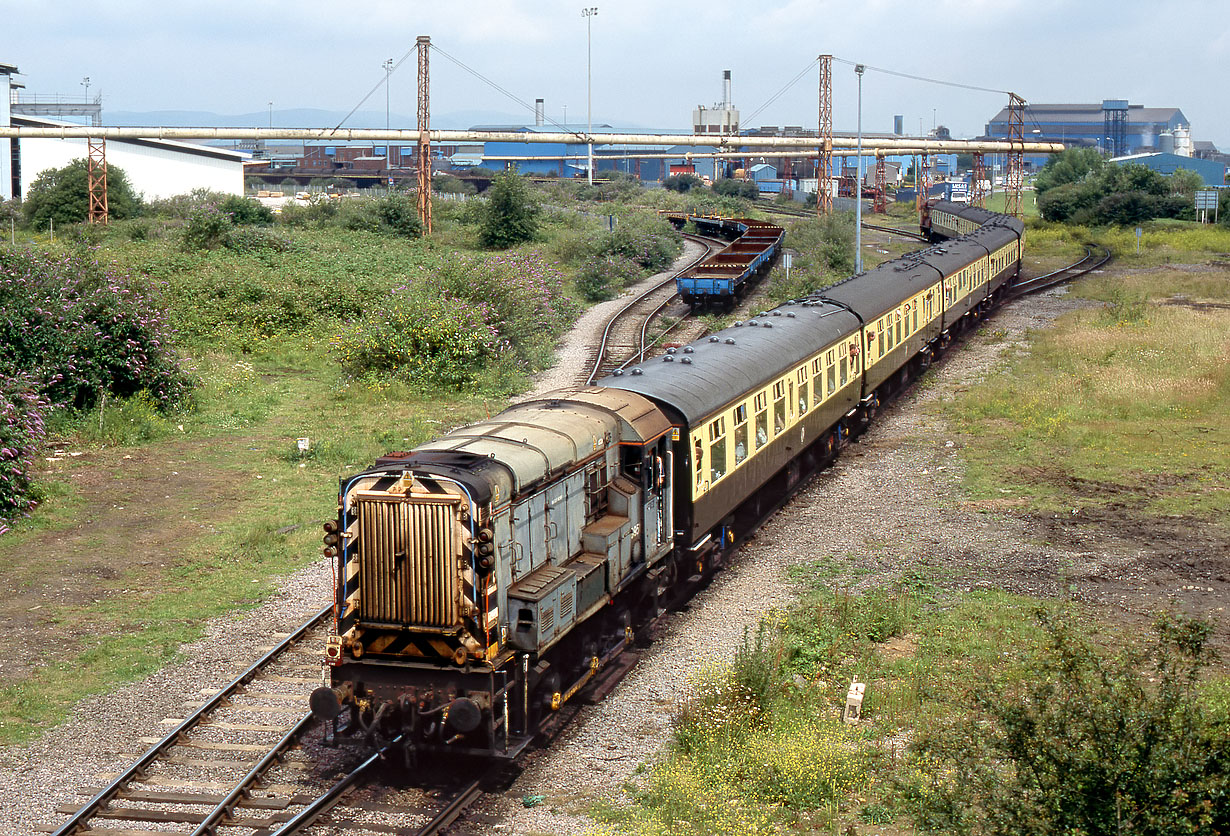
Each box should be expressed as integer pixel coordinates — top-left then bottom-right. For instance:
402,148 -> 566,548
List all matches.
595,301 -> 859,424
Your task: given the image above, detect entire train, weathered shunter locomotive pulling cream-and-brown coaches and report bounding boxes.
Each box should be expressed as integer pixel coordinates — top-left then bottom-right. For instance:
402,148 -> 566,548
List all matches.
311,203 -> 1023,759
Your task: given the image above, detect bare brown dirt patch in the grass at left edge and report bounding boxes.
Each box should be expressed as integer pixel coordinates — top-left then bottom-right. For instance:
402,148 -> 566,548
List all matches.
0,439 -> 253,685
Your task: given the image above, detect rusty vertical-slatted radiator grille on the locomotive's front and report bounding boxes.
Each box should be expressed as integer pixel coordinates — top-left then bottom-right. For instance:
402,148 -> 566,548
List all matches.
357,494 -> 460,628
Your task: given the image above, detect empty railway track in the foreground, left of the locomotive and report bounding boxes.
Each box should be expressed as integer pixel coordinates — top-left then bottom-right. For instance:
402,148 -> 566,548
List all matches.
47,606 -> 353,836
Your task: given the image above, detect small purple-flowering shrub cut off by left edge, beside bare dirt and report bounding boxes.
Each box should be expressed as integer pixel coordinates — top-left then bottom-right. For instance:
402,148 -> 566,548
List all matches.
0,374 -> 47,534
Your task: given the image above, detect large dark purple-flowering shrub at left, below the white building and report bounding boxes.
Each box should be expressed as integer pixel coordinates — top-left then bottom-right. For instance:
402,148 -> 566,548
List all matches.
0,248 -> 188,409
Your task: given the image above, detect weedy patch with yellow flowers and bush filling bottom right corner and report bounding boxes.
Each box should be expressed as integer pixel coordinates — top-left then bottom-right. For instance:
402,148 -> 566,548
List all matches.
594,570 -> 1230,836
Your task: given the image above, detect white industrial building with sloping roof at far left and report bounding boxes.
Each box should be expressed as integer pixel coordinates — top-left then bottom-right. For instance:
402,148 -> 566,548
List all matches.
0,64 -> 248,200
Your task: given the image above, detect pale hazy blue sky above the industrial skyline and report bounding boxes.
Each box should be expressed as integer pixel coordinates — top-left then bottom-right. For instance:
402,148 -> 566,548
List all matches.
9,0 -> 1230,150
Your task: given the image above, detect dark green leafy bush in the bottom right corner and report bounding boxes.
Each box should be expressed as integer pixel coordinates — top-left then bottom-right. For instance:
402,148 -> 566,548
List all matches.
907,613 -> 1230,836
